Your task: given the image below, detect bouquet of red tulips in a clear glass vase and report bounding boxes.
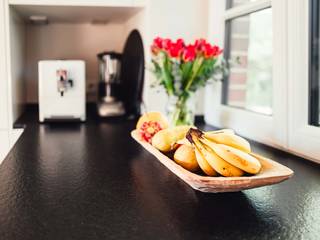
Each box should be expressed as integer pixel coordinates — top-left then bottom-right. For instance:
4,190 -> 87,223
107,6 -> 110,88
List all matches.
151,37 -> 224,125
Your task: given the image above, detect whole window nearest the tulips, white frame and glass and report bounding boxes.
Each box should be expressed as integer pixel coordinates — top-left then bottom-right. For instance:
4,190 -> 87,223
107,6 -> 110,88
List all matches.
205,0 -> 291,150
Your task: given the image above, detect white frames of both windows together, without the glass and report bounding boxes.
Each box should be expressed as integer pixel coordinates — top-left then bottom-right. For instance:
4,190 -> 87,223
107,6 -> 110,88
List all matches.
205,0 -> 320,163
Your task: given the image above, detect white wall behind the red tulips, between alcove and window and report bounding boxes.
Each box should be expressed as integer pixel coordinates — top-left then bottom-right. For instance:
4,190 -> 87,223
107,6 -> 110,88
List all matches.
144,0 -> 209,114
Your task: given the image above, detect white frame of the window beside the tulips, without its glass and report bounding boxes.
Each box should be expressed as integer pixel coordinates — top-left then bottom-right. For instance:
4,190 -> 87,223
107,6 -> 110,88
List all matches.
205,0 -> 287,148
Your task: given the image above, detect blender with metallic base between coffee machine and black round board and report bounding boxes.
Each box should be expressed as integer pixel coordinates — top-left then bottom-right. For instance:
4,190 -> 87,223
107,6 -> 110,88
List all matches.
97,52 -> 125,117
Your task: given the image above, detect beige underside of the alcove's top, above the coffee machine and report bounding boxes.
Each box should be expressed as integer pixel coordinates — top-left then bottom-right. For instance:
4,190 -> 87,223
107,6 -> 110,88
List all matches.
11,5 -> 142,23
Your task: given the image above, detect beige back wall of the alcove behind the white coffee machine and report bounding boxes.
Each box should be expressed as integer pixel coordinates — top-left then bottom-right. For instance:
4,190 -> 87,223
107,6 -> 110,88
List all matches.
25,23 -> 126,103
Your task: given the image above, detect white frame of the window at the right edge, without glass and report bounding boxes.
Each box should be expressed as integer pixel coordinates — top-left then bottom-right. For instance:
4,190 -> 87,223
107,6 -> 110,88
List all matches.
288,0 -> 320,163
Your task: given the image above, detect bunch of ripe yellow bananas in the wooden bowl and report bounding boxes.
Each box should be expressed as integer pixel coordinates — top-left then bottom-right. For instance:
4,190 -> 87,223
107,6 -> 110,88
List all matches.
186,128 -> 261,177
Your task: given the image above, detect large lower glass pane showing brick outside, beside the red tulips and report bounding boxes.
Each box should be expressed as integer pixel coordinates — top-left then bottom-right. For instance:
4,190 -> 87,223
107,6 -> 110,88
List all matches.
223,8 -> 272,115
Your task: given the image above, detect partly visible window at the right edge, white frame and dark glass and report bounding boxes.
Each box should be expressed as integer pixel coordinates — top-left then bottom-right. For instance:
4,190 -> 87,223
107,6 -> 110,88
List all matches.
287,0 -> 320,163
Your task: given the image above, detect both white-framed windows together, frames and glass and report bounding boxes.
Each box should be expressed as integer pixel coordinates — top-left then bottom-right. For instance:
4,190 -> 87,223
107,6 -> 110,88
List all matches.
205,0 -> 320,163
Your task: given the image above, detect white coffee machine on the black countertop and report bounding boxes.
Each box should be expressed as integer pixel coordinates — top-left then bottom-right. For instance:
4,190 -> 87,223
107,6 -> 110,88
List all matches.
38,60 -> 86,122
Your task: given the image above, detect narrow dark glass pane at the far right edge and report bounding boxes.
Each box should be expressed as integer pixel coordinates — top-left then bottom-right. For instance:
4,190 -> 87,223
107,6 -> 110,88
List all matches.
309,0 -> 320,126
